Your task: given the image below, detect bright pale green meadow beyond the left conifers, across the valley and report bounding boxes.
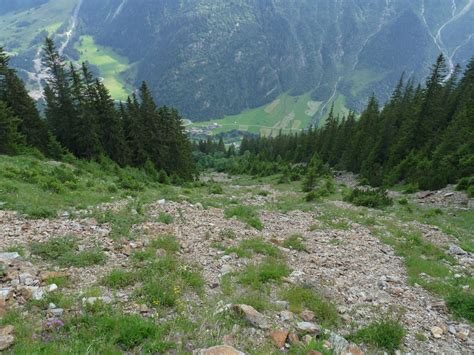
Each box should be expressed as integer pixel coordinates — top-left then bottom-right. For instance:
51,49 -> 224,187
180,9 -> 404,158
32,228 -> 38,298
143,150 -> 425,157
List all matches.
74,36 -> 130,100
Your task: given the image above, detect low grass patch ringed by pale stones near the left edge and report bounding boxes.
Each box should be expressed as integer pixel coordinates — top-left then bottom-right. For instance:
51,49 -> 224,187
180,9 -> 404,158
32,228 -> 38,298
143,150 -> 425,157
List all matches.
30,236 -> 106,267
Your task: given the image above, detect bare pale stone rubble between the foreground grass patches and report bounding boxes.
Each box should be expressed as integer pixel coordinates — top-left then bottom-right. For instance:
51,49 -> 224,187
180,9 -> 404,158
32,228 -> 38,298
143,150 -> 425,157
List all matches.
0,177 -> 474,354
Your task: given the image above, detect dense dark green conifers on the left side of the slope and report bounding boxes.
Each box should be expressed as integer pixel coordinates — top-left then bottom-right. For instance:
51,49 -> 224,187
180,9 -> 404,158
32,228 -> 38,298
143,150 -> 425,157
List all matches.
0,38 -> 195,179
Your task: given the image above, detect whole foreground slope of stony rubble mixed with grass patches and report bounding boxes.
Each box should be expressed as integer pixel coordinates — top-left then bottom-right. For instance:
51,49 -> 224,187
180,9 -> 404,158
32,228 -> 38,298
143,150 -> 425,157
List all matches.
0,171 -> 474,354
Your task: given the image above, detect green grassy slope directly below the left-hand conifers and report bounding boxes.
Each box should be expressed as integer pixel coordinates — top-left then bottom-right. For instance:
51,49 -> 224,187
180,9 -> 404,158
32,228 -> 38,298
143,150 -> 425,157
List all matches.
0,155 -> 176,223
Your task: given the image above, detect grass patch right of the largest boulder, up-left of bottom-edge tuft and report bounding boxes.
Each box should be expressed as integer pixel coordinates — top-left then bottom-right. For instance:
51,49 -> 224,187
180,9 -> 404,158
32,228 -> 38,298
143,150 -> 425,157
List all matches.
282,286 -> 339,327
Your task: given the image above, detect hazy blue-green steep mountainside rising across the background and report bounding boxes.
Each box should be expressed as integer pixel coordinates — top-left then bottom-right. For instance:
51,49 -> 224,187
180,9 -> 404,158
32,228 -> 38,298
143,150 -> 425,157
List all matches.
0,0 -> 474,123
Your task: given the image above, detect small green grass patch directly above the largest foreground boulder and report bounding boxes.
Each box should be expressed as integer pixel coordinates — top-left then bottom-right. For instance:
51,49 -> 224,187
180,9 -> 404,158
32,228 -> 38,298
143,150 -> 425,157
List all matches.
239,257 -> 291,289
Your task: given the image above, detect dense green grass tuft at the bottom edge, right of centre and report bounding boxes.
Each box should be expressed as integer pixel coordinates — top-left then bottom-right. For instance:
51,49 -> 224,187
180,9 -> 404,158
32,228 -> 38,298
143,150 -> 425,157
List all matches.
349,317 -> 406,353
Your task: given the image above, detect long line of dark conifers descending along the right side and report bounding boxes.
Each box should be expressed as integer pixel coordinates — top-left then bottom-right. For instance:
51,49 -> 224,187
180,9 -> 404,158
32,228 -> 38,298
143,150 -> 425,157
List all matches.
232,55 -> 474,189
